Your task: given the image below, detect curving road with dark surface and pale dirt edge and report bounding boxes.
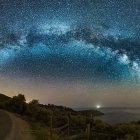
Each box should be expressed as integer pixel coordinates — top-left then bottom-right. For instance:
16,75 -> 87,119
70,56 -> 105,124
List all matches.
0,110 -> 34,140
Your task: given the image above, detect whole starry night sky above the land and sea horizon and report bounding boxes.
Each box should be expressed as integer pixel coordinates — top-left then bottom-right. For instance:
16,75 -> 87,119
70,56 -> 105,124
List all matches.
0,0 -> 140,107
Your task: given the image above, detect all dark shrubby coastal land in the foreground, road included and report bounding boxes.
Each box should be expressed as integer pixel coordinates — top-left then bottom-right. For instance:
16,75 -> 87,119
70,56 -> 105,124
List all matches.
0,94 -> 140,140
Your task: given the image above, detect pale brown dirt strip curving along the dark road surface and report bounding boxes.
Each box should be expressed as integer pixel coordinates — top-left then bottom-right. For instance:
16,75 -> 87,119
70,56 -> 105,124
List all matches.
5,112 -> 34,140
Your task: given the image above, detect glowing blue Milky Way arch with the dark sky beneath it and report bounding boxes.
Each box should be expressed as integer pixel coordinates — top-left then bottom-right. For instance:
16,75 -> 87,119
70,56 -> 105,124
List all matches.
0,23 -> 140,81
